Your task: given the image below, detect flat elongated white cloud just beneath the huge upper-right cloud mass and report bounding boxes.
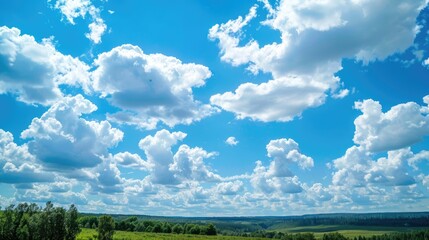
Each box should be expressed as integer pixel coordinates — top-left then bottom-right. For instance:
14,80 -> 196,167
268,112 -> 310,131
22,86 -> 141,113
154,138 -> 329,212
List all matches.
210,77 -> 336,122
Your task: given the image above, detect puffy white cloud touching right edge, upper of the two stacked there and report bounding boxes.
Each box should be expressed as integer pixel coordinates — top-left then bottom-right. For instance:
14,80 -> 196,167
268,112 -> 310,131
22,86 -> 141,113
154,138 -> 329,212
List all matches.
353,96 -> 429,152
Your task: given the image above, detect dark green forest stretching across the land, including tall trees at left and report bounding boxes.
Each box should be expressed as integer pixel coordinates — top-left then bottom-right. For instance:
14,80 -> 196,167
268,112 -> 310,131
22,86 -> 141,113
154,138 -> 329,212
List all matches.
0,202 -> 429,240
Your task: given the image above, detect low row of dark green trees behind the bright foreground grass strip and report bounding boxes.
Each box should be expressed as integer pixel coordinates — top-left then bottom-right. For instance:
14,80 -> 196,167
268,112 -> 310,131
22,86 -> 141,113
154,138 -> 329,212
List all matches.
79,216 -> 217,235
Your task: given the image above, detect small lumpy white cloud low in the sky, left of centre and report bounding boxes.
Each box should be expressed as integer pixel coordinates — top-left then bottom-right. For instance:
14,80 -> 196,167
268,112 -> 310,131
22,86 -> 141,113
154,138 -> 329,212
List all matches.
139,130 -> 221,185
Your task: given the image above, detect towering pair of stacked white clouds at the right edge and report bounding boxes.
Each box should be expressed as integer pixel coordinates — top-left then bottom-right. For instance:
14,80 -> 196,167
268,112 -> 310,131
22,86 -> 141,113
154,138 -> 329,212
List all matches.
332,96 -> 429,187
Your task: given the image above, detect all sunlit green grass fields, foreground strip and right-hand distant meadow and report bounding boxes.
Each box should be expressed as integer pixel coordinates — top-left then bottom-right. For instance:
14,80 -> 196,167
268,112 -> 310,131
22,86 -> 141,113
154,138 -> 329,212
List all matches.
77,225 -> 422,240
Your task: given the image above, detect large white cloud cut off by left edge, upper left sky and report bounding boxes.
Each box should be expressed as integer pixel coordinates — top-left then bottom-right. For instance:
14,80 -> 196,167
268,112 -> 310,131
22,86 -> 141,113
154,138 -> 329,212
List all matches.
0,27 -> 89,105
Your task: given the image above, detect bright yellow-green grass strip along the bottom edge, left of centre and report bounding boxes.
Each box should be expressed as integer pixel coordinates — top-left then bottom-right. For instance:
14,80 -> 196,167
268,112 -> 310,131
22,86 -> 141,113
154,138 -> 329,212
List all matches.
77,228 -> 267,240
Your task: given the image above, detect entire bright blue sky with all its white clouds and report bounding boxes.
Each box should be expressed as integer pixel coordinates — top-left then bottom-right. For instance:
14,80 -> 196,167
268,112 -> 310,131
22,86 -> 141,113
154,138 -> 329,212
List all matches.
0,0 -> 429,216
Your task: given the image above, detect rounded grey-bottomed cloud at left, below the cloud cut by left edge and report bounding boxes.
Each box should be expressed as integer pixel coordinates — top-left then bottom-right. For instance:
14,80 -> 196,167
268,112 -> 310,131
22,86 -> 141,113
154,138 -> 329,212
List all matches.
21,95 -> 123,172
